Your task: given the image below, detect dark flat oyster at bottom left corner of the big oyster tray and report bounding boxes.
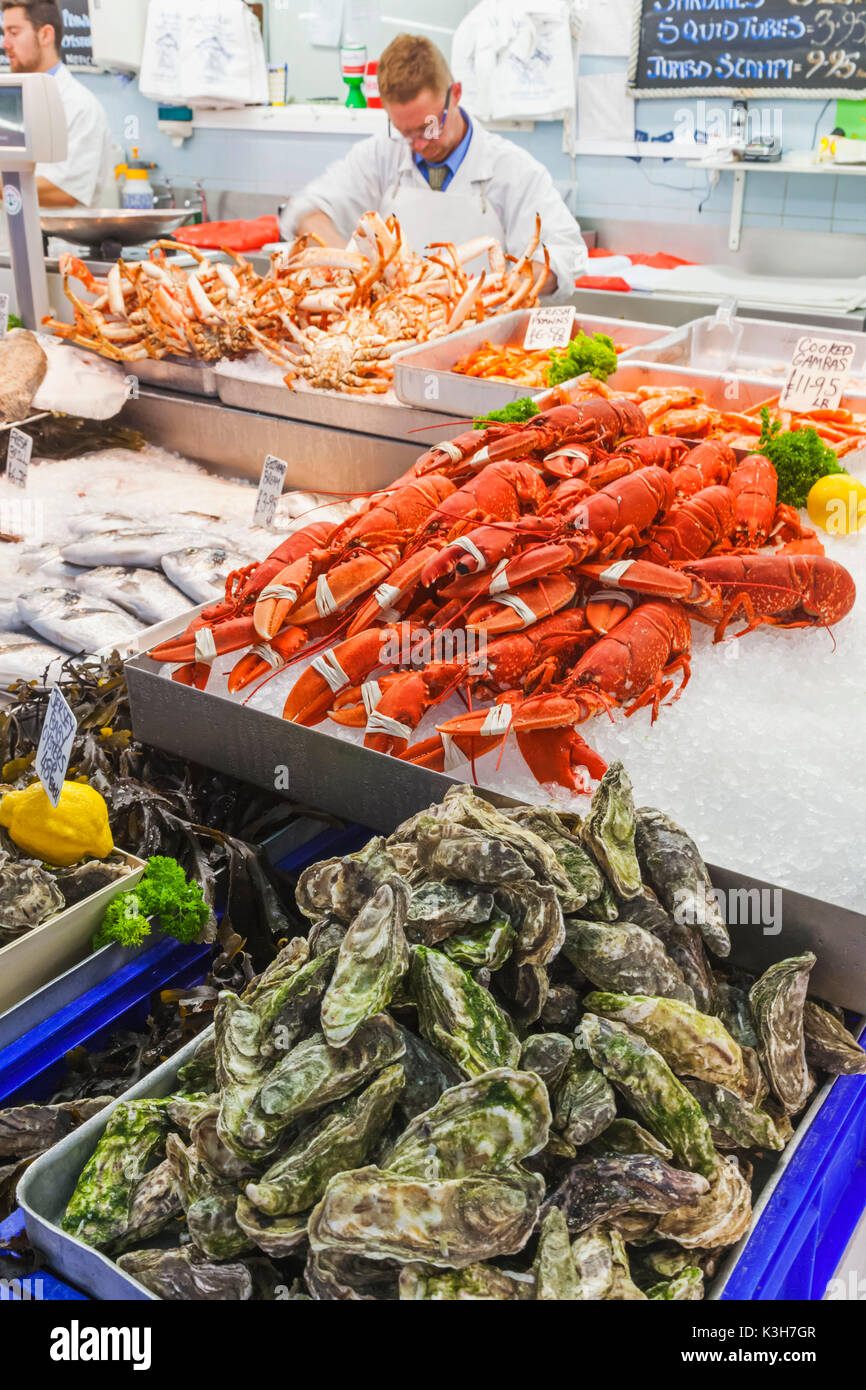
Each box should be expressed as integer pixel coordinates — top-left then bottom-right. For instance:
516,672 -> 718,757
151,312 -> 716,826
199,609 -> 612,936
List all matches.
118,1245 -> 282,1302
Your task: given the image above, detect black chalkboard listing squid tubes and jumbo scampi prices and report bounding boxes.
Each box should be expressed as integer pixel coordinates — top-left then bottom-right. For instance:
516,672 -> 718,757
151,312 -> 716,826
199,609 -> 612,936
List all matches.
628,0 -> 866,99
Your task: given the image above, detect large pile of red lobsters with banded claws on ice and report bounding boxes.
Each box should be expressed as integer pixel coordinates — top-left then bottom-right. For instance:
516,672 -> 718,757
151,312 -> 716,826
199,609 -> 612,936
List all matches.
145,399 -> 855,790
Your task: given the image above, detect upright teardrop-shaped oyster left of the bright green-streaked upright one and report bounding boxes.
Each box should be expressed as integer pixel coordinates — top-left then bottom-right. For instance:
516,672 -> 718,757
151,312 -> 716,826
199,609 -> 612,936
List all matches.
321,878 -> 409,1047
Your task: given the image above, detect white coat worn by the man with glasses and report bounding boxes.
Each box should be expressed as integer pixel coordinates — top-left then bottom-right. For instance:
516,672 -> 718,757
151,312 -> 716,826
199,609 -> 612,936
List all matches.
282,120 -> 587,297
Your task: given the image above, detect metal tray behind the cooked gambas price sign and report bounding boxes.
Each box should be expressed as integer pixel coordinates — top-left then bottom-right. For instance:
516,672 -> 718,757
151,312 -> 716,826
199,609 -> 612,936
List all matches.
632,316 -> 866,391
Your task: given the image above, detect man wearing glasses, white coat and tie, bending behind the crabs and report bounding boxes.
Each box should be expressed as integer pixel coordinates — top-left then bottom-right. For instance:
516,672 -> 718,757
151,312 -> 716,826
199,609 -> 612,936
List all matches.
286,33 -> 587,297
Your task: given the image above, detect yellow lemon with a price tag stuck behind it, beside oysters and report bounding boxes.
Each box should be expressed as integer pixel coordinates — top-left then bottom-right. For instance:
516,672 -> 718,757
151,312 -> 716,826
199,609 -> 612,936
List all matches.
0,781 -> 114,869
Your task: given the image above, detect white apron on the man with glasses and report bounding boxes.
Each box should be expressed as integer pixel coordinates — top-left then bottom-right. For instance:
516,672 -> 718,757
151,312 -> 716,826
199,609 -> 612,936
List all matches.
378,170 -> 505,275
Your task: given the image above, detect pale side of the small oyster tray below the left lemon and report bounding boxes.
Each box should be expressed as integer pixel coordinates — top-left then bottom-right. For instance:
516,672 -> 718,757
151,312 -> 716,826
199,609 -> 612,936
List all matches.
0,853 -> 146,1020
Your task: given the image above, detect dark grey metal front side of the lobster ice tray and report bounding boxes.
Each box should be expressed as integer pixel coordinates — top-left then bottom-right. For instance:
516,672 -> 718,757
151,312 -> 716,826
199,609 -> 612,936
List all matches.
125,644 -> 866,1013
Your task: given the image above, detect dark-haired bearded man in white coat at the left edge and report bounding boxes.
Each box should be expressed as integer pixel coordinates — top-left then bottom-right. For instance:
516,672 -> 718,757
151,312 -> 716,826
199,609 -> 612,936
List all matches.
3,0 -> 113,207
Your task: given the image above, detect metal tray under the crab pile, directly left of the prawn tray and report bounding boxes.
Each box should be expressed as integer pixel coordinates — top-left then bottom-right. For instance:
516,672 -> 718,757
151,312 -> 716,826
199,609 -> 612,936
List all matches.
215,361 -> 453,442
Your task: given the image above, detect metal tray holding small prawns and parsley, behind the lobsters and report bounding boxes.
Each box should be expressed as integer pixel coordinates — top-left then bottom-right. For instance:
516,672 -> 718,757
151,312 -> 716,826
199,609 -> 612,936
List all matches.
393,309 -> 666,420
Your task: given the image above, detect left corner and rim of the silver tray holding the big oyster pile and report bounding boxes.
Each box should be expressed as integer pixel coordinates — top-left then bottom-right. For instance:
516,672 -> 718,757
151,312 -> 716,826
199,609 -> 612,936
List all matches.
17,1034 -> 204,1302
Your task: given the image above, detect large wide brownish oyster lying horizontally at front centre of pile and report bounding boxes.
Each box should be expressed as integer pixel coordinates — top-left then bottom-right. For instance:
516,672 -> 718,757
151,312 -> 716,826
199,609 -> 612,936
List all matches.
309,1168 -> 545,1269
